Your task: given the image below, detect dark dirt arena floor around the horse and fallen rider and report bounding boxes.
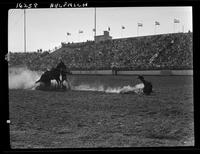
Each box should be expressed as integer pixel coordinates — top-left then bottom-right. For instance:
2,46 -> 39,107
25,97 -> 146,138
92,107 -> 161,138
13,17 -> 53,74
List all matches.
9,75 -> 194,149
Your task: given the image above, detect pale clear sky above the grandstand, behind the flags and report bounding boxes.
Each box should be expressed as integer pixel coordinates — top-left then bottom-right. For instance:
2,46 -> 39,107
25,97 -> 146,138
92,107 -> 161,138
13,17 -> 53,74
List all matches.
8,7 -> 192,52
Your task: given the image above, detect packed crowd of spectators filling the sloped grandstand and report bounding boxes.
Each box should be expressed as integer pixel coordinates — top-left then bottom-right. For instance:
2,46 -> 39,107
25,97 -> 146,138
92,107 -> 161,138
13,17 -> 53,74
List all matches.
9,32 -> 193,70
